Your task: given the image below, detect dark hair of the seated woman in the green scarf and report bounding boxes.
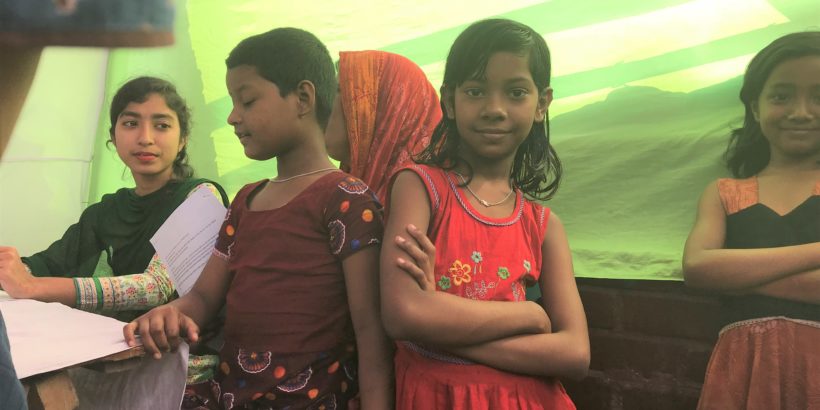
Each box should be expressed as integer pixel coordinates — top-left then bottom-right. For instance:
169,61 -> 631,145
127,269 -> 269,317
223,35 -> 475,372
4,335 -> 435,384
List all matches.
108,77 -> 194,180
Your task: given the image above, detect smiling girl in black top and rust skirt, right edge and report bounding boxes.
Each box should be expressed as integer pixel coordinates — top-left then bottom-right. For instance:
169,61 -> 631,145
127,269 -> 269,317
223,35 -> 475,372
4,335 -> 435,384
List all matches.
683,32 -> 820,409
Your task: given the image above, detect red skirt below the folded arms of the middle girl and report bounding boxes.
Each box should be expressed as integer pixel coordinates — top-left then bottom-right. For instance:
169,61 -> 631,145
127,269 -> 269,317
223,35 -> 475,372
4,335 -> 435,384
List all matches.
395,343 -> 575,410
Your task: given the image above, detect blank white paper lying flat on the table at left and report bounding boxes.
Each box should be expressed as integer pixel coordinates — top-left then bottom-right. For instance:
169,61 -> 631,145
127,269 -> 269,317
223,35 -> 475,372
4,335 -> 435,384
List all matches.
0,292 -> 129,379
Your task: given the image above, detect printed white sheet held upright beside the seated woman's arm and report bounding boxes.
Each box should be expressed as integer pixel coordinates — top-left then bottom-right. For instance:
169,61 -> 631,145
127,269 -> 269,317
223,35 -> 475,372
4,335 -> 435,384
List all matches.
151,187 -> 227,296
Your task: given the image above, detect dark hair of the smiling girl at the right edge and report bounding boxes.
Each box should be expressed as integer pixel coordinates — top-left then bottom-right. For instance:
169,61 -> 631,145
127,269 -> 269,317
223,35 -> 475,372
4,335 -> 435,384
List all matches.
724,31 -> 820,178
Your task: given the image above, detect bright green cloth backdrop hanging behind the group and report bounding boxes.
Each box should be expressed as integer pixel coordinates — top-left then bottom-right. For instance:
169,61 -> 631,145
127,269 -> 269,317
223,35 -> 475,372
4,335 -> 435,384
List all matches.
89,0 -> 820,279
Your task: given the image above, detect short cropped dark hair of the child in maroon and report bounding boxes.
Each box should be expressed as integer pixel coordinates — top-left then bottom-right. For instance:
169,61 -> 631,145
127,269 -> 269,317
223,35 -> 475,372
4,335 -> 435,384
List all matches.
225,27 -> 338,130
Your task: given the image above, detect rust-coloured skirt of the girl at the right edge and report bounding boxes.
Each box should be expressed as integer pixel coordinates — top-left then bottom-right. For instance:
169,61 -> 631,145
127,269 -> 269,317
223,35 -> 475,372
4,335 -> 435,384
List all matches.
698,317 -> 820,410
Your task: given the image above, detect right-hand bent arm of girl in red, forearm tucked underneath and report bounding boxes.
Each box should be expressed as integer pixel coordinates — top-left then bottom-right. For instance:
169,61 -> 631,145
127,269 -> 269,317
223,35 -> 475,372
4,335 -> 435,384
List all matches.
450,214 -> 590,379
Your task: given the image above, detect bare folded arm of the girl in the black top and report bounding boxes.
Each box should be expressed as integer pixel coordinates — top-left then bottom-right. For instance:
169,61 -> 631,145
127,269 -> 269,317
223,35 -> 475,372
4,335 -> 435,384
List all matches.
683,182 -> 820,291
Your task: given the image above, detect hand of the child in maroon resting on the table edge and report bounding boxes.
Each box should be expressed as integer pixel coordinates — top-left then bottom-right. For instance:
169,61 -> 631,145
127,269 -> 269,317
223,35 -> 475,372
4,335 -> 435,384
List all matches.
122,305 -> 199,359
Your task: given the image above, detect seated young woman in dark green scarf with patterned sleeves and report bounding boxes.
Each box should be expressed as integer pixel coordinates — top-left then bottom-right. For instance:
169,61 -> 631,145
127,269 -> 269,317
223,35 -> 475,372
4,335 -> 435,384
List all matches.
0,77 -> 228,321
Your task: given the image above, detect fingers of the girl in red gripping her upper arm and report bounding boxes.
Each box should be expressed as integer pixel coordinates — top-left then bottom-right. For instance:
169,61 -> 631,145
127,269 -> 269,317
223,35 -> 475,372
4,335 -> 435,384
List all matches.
396,224 -> 436,292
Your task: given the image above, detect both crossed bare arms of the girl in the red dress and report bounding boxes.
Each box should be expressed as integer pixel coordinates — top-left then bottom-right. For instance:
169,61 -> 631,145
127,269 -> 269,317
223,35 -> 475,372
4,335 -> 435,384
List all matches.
381,172 -> 589,378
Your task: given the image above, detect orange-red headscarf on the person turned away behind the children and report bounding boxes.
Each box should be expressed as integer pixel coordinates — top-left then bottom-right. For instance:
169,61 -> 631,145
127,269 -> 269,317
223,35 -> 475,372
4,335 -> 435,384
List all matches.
339,51 -> 441,202
